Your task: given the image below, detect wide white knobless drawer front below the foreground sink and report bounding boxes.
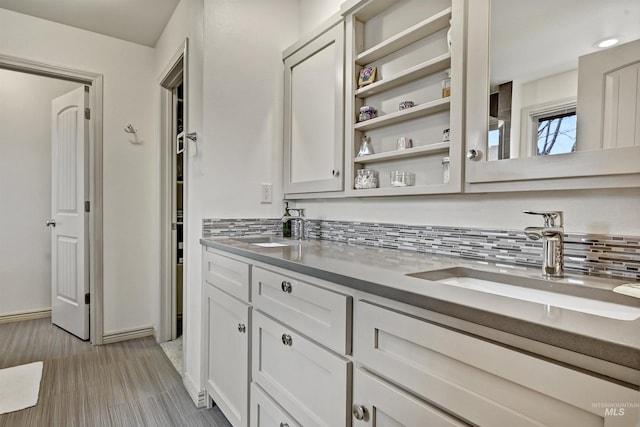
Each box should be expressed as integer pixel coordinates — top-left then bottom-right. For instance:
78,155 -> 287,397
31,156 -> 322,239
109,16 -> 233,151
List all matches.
353,301 -> 638,426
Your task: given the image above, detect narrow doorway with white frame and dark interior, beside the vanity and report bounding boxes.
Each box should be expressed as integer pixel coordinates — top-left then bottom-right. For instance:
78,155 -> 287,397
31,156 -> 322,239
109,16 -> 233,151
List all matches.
158,42 -> 188,374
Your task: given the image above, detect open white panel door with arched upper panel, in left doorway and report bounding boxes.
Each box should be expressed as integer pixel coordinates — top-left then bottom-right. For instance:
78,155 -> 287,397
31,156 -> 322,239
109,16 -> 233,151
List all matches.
48,87 -> 89,340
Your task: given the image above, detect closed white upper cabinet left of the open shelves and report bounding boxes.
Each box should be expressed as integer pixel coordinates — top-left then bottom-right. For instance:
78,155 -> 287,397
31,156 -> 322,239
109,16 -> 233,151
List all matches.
283,16 -> 344,198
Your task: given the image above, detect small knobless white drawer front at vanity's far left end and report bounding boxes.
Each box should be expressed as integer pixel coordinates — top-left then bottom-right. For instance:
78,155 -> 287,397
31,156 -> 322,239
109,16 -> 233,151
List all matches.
202,248 -> 251,302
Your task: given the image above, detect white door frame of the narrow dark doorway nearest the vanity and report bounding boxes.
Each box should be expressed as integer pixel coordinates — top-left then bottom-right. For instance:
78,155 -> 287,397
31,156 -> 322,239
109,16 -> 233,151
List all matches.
156,39 -> 189,344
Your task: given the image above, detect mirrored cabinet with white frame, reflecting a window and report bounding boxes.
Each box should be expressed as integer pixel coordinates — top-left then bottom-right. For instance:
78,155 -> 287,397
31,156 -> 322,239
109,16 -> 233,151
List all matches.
467,0 -> 640,188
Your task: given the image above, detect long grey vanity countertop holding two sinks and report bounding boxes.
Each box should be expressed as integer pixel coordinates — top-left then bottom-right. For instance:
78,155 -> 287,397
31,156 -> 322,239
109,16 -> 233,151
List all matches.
200,238 -> 640,385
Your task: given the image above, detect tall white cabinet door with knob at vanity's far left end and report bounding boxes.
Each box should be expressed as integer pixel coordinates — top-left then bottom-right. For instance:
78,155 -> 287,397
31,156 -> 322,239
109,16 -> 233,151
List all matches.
204,283 -> 251,427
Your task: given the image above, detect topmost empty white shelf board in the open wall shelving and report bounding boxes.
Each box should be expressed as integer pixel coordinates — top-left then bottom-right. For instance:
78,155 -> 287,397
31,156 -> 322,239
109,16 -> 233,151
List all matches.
355,7 -> 451,65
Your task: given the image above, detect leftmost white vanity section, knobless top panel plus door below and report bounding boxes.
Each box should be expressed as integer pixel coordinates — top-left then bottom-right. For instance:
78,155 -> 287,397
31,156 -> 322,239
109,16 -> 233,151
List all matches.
202,250 -> 251,427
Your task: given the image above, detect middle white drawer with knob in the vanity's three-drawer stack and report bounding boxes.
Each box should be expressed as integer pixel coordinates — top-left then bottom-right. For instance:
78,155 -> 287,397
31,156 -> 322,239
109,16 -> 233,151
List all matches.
252,311 -> 351,427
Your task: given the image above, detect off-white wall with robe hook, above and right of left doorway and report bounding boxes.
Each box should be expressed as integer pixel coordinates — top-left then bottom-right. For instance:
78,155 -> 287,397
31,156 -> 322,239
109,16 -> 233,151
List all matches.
0,9 -> 159,334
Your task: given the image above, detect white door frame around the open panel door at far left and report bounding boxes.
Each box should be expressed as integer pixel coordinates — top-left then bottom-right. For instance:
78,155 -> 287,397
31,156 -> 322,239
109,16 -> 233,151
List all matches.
0,54 -> 104,345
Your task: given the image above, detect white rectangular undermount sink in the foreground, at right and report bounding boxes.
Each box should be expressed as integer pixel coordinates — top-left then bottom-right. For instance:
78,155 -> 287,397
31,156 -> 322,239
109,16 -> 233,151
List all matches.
407,267 -> 640,320
